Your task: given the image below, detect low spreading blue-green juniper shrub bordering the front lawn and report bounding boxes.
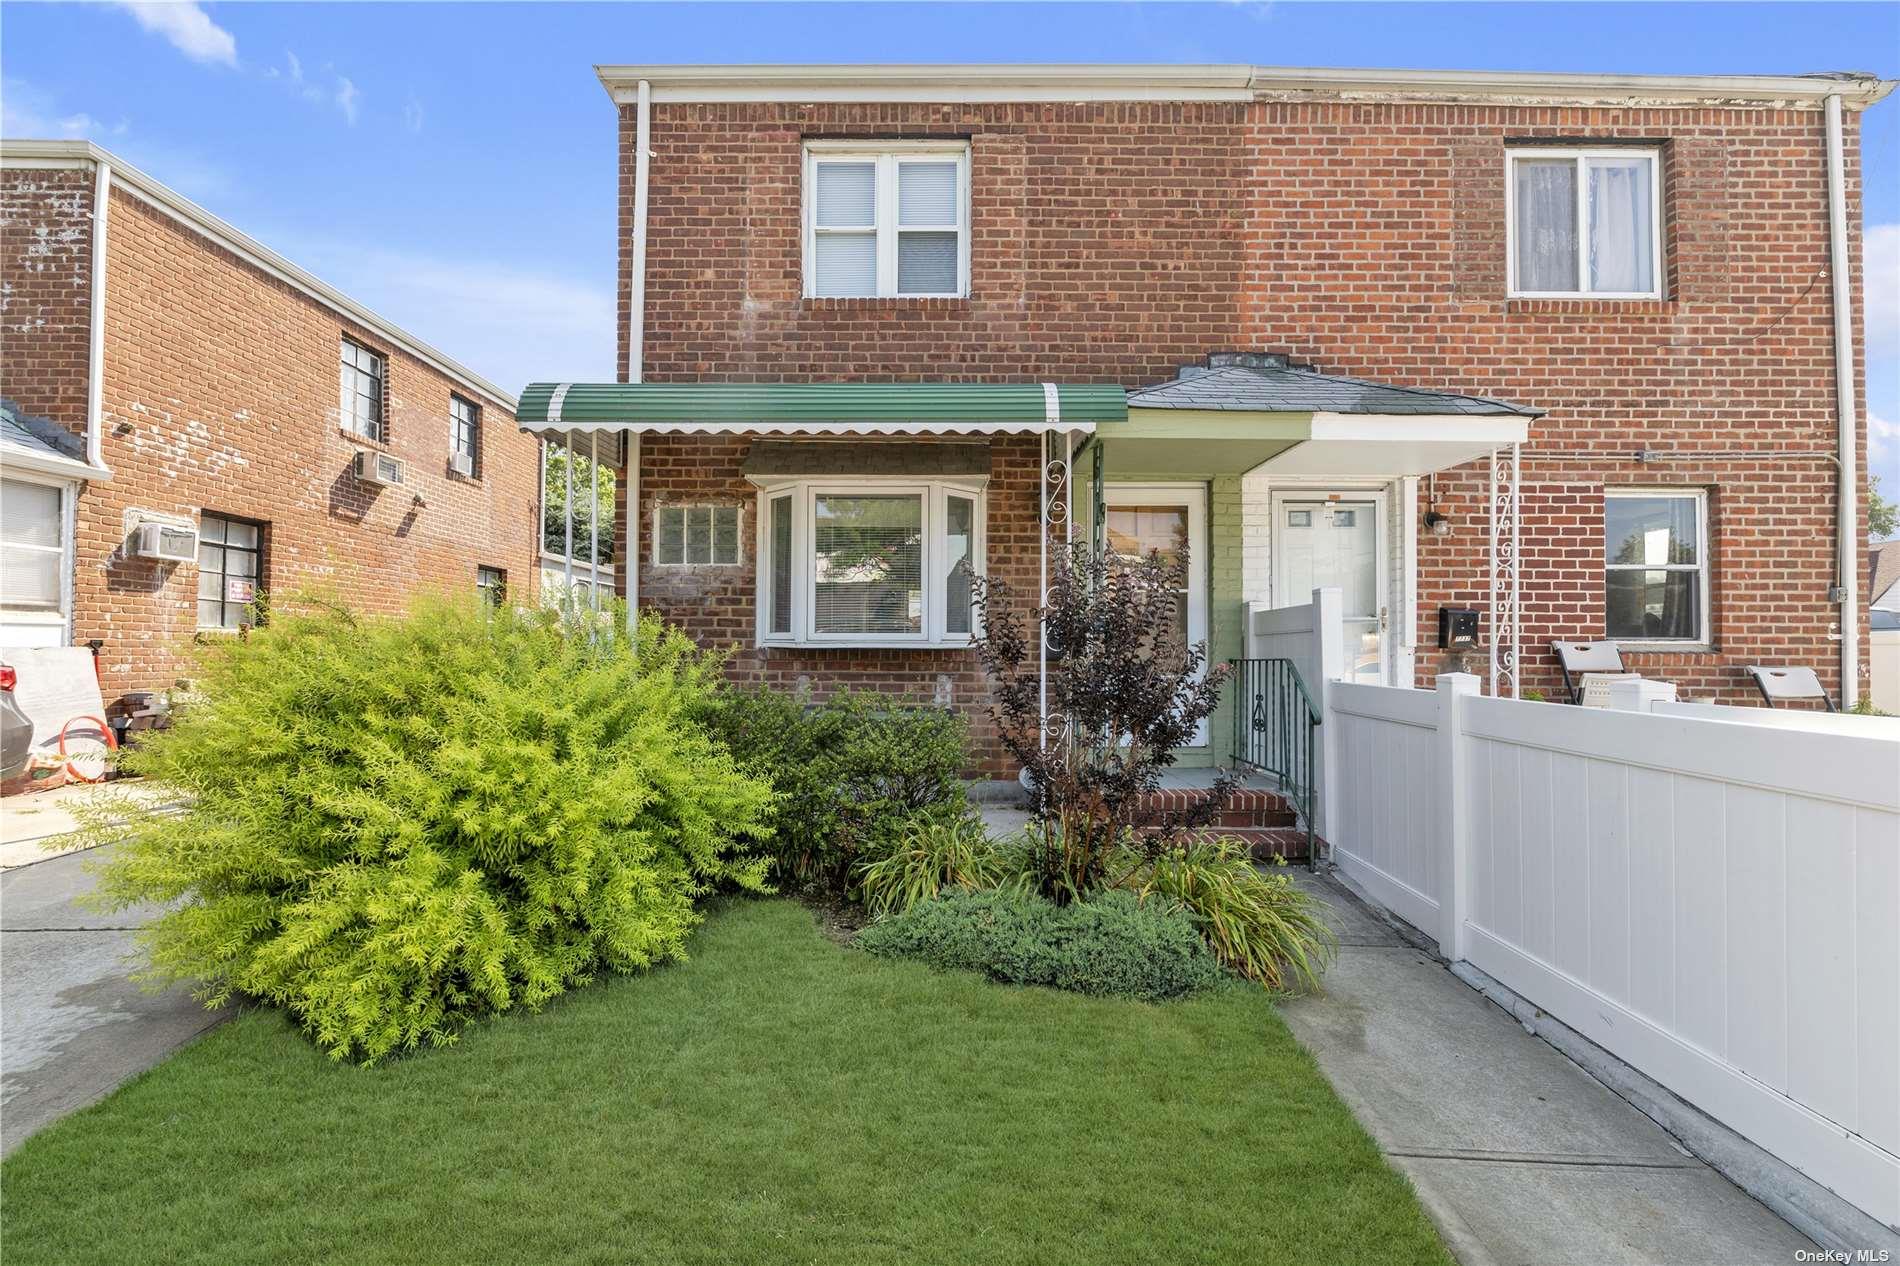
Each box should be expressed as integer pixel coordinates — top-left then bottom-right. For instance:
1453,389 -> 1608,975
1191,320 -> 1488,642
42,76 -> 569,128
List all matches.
857,890 -> 1224,1002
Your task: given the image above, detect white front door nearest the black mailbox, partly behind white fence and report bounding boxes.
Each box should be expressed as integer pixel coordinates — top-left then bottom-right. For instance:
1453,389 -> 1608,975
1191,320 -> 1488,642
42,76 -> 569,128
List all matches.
1273,492 -> 1385,682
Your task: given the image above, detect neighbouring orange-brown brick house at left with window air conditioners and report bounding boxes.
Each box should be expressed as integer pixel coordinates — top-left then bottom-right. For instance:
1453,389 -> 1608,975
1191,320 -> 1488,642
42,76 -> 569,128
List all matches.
0,141 -> 540,703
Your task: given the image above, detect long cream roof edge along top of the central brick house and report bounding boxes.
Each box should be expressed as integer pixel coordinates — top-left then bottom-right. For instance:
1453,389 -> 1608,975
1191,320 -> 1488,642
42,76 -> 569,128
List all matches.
595,63 -> 1896,108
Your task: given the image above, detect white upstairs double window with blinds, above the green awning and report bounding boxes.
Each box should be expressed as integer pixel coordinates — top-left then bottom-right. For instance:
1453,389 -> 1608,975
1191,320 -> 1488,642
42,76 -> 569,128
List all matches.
804,141 -> 969,298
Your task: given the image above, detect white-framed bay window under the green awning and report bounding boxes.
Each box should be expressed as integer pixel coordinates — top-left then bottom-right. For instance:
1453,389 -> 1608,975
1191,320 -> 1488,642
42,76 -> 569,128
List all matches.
758,479 -> 982,646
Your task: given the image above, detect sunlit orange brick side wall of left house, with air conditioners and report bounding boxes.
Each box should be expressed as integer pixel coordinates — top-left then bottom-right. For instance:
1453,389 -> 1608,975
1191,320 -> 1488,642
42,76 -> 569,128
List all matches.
74,190 -> 540,700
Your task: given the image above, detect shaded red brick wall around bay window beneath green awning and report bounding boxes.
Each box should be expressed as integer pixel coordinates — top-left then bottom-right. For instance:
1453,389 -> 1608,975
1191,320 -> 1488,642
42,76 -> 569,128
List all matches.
616,435 -> 1041,774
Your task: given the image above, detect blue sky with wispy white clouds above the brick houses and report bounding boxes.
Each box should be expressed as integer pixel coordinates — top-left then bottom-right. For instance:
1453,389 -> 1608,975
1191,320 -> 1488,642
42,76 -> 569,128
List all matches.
0,0 -> 1900,494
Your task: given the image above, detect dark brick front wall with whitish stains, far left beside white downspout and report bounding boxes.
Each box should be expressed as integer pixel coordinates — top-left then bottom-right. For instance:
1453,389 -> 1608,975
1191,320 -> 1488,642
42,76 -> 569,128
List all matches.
0,167 -> 93,446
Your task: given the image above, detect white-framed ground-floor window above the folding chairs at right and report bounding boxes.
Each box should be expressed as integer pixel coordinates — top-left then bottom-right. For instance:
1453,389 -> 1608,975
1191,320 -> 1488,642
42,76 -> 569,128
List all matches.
1604,490 -> 1710,644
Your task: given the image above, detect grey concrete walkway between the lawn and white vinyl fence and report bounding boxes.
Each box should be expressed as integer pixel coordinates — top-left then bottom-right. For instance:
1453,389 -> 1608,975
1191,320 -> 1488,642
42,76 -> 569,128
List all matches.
1281,871 -> 1813,1266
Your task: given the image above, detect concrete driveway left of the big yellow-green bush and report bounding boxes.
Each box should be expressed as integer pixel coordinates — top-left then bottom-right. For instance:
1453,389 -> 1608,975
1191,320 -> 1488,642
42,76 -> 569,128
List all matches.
0,844 -> 224,1156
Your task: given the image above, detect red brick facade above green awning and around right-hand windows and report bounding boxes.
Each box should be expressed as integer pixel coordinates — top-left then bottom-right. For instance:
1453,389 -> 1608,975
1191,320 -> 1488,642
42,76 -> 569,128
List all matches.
619,101 -> 1866,701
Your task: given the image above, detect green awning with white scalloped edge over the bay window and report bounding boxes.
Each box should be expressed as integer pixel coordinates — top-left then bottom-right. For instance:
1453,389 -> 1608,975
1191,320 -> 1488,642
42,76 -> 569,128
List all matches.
515,382 -> 1129,435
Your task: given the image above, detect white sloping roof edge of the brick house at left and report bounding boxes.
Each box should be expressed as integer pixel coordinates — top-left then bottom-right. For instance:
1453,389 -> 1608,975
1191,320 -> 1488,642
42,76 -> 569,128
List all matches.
0,139 -> 517,412
